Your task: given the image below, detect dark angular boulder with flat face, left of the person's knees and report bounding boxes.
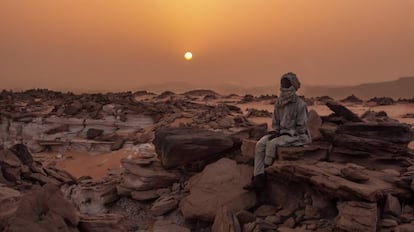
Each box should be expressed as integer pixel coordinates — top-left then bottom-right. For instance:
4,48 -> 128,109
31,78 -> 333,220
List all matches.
154,128 -> 235,168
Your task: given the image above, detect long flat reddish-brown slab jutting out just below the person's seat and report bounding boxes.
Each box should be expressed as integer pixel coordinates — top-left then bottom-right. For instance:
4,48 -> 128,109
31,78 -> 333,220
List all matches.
266,161 -> 410,202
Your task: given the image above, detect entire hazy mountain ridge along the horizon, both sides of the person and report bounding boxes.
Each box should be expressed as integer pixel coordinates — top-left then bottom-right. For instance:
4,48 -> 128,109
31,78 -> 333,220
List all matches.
139,77 -> 414,99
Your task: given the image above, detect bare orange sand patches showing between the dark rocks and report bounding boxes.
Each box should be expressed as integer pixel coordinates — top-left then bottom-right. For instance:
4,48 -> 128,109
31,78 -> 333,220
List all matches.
35,96 -> 414,178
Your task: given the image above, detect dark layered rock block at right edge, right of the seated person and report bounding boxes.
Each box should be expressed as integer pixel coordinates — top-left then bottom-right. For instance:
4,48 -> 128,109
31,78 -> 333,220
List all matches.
329,123 -> 412,170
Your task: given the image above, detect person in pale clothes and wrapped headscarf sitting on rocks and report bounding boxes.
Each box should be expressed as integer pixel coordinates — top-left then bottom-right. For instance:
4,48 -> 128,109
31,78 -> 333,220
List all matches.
244,72 -> 312,190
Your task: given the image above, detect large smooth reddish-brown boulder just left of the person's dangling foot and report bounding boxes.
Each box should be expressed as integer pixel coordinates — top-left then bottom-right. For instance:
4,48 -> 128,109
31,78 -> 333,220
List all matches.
180,158 -> 256,221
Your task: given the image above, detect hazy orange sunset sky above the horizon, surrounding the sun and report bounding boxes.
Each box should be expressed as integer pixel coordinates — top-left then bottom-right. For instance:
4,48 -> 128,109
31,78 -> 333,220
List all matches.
0,0 -> 414,90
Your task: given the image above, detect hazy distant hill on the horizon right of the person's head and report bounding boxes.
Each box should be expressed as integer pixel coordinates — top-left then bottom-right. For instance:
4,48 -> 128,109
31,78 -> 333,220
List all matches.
303,77 -> 414,99
